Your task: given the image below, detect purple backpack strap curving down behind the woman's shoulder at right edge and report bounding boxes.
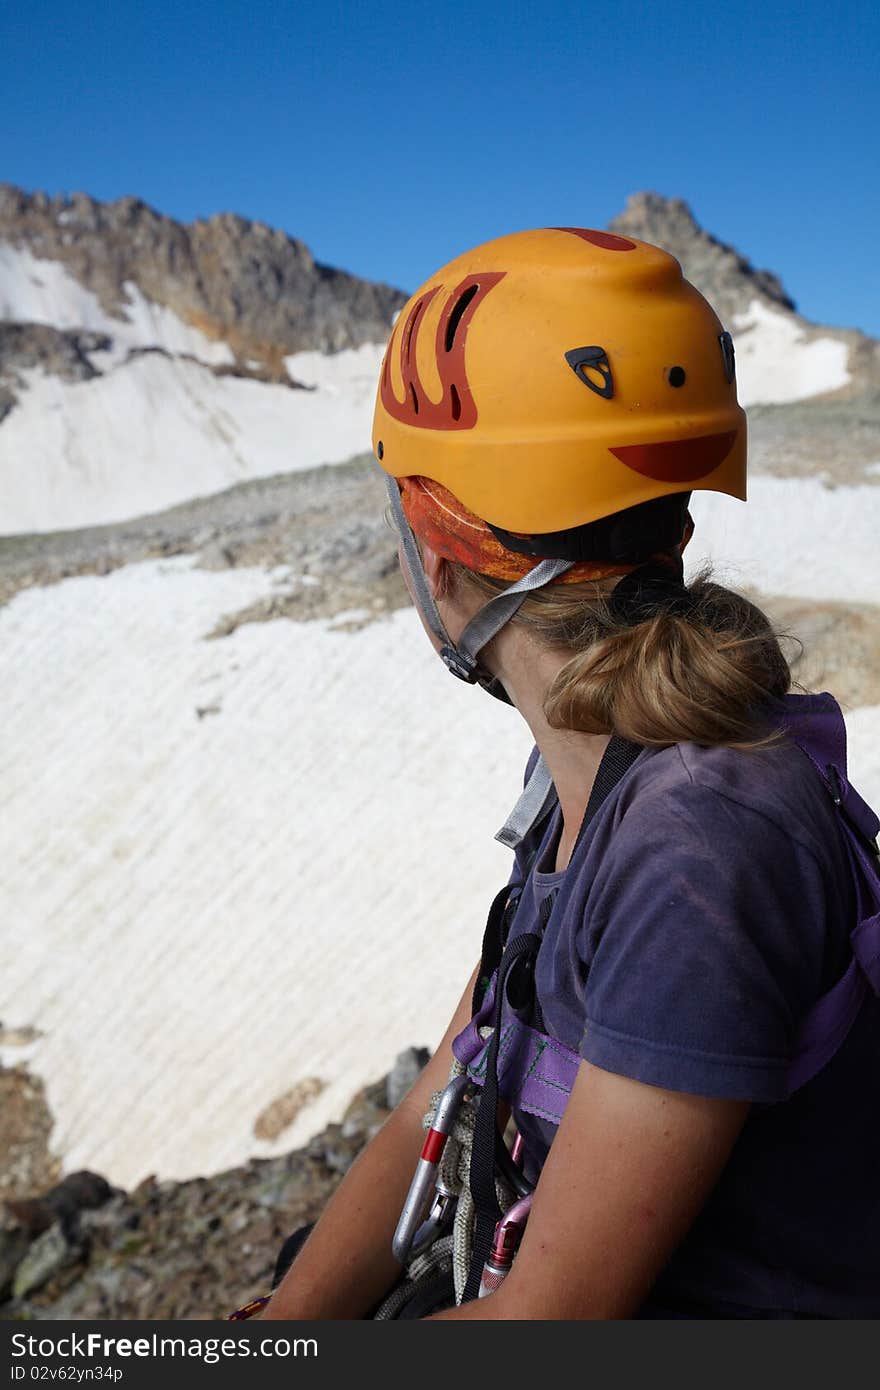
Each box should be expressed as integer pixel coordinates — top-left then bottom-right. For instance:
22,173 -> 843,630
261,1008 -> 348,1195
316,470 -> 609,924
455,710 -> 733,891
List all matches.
784,692 -> 880,1095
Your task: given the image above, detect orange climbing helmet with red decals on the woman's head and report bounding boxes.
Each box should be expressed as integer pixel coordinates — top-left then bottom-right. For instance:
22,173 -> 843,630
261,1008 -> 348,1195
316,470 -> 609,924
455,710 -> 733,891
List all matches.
373,228 -> 747,578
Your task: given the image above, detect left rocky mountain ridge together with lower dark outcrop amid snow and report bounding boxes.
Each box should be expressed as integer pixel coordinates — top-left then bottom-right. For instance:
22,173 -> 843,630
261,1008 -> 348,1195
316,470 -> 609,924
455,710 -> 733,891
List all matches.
0,183 -> 406,423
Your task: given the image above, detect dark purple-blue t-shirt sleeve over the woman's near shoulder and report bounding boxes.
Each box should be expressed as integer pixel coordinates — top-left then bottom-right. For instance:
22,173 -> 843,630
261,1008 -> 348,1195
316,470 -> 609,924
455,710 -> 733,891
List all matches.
564,695 -> 852,1101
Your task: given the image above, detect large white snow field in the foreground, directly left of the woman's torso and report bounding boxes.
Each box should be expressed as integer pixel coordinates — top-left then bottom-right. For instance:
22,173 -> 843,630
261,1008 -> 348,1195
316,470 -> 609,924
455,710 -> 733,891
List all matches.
0,562 -> 531,1186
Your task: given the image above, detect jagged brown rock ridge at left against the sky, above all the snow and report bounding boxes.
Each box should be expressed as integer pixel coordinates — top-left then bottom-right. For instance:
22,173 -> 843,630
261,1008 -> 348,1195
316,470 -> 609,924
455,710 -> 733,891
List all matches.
0,183 -> 406,371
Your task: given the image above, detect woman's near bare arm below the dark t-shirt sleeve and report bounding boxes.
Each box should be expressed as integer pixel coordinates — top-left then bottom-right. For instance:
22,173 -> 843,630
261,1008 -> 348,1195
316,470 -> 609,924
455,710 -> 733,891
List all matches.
425,1062 -> 749,1319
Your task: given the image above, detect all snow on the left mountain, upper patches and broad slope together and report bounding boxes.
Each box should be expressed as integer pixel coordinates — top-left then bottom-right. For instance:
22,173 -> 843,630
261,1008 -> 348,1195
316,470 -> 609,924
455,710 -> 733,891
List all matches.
0,242 -> 384,535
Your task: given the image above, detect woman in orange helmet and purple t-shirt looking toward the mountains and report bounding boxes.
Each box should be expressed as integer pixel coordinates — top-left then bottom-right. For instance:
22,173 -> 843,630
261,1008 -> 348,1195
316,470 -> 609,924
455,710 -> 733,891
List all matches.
246,228 -> 880,1319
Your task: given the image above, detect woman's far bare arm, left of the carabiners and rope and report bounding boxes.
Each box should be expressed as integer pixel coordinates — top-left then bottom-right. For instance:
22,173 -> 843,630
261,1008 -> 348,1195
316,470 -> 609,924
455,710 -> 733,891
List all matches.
260,970 -> 477,1319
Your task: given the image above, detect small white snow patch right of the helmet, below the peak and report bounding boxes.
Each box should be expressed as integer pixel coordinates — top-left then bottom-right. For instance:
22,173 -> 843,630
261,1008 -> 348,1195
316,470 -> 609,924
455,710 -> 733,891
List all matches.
733,299 -> 851,406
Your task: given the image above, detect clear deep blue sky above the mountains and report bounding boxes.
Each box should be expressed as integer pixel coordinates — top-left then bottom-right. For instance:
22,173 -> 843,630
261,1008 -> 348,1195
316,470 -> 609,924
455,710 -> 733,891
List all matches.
0,0 -> 880,336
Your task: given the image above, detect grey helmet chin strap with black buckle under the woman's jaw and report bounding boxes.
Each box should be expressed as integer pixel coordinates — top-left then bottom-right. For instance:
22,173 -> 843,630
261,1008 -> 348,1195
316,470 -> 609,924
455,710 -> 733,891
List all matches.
385,475 -> 574,705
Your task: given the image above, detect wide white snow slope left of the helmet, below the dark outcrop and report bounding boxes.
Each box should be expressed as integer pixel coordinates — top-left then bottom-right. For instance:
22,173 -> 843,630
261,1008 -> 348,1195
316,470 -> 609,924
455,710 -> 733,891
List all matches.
0,346 -> 382,535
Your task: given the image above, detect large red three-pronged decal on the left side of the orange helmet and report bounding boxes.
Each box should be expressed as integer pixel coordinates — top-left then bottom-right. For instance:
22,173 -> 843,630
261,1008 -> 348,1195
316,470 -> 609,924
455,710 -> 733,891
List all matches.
381,270 -> 505,430
